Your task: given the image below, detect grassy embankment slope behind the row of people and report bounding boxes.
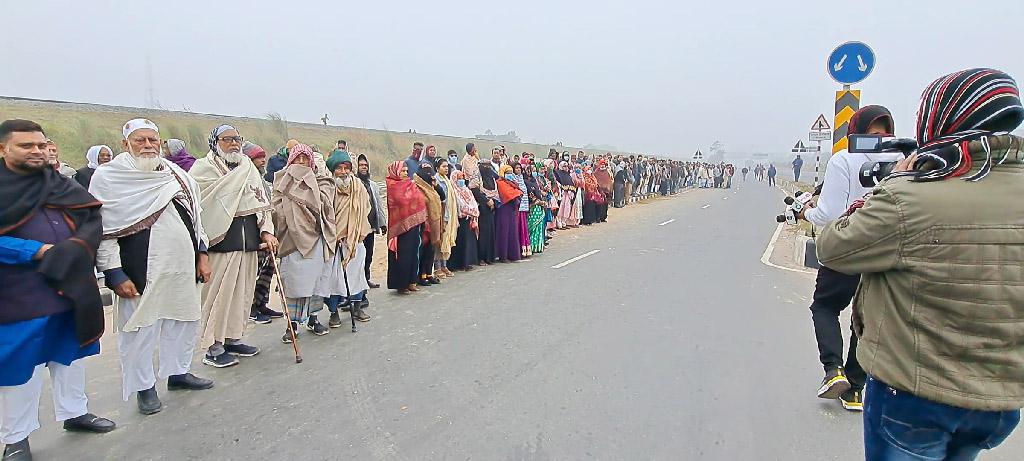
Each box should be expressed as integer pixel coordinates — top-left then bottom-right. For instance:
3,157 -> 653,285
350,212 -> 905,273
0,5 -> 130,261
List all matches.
0,97 -> 630,176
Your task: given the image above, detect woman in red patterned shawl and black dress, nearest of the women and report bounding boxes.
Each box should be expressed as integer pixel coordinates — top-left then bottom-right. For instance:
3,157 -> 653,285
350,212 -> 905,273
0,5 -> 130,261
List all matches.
386,160 -> 427,293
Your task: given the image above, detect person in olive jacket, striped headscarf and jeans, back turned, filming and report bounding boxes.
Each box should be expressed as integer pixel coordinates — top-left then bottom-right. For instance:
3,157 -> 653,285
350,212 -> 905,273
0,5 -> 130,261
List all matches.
817,69 -> 1024,460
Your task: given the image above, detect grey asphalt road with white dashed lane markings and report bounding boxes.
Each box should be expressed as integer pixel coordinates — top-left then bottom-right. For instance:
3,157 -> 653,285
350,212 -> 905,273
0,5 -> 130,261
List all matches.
19,181 -> 1024,460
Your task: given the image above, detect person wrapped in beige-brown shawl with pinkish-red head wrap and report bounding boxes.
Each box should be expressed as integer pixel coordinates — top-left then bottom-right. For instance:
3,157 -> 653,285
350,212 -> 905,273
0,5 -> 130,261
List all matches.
271,143 -> 338,344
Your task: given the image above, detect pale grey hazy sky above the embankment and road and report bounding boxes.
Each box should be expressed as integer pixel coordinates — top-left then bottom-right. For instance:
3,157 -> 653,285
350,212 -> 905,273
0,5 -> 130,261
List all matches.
0,0 -> 1024,155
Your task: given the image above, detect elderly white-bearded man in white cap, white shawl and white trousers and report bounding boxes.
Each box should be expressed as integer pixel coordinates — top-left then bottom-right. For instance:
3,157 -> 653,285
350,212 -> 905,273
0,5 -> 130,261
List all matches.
89,119 -> 213,415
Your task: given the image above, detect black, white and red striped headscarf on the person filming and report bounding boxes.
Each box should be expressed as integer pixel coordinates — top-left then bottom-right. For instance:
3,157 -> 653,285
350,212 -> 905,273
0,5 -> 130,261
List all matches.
911,69 -> 1024,181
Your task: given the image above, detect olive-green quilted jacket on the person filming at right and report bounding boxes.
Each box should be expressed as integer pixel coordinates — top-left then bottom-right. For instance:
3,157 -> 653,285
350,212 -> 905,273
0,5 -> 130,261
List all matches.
817,135 -> 1024,411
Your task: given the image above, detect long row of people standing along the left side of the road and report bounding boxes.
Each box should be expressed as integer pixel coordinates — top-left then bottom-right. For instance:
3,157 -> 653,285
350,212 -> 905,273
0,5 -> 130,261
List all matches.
0,115 -> 688,456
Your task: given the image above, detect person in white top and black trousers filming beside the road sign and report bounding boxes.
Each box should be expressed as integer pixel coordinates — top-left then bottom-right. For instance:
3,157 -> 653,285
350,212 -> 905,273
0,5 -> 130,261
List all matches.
798,106 -> 900,411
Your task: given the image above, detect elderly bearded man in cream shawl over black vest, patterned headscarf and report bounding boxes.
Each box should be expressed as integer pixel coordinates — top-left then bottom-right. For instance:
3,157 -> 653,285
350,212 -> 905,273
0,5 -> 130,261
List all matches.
188,125 -> 278,368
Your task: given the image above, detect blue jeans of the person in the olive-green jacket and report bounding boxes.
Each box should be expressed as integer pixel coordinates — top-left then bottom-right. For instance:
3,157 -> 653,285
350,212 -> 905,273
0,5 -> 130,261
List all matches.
864,378 -> 1021,461
